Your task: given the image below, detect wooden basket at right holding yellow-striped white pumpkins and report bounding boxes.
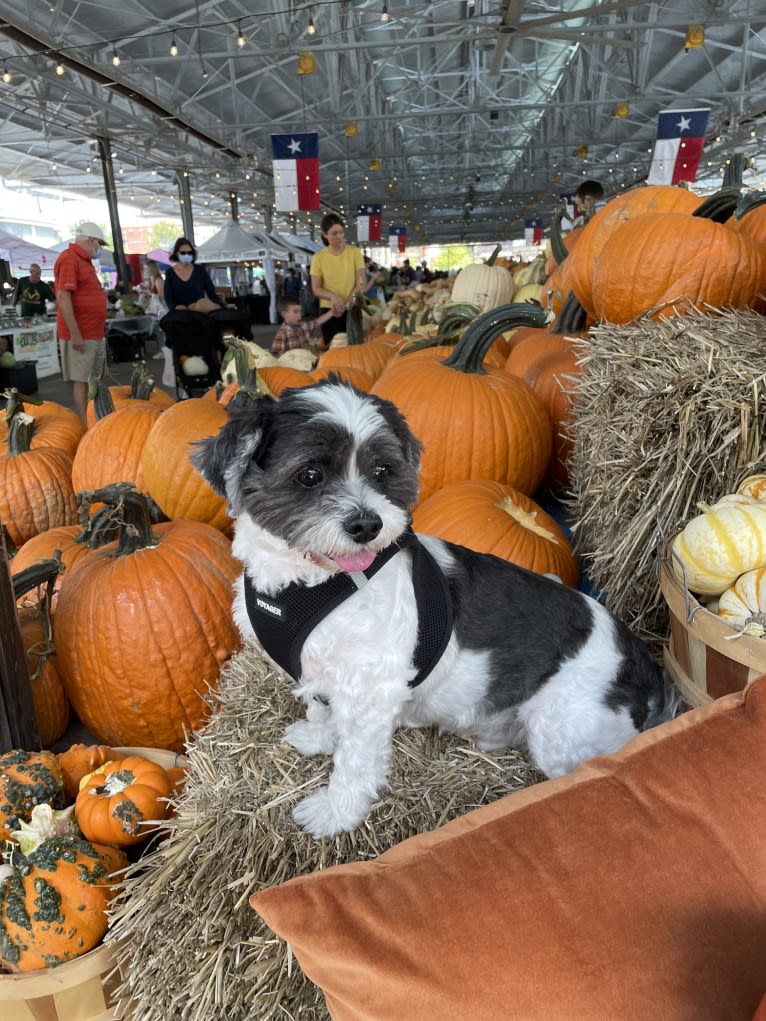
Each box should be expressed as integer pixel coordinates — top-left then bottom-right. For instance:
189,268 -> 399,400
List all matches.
660,540 -> 766,706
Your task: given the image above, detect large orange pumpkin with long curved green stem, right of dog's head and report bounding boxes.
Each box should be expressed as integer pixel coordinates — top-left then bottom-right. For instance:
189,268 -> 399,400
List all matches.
372,304 -> 553,499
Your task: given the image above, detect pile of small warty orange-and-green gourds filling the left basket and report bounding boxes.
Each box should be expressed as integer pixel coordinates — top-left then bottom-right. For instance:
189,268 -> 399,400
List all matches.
0,744 -> 184,972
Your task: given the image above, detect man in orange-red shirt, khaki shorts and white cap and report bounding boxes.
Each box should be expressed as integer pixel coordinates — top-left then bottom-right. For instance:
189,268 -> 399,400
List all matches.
53,222 -> 108,421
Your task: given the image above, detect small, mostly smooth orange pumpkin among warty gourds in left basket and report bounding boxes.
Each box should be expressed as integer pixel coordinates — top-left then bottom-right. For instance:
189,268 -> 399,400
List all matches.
75,756 -> 173,847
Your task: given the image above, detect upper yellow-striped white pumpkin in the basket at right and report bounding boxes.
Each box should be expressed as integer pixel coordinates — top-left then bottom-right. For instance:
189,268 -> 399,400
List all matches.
672,503 -> 766,595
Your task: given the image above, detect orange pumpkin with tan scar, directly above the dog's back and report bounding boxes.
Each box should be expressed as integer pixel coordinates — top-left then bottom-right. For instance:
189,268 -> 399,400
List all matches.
413,479 -> 579,586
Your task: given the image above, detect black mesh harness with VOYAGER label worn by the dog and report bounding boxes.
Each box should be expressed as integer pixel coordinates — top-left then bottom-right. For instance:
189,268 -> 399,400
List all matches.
244,531 -> 452,687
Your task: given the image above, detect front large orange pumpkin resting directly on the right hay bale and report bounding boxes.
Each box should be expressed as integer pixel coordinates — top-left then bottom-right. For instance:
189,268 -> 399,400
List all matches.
592,212 -> 766,323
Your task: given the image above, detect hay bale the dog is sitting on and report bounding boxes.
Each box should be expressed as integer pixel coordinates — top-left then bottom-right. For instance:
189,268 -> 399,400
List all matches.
108,644 -> 542,1021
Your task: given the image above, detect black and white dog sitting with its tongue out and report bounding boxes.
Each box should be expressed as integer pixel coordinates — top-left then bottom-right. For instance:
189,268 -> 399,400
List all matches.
192,379 -> 676,836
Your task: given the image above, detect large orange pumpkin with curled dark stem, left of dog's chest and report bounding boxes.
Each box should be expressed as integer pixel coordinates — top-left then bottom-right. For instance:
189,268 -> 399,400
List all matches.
53,481 -> 241,751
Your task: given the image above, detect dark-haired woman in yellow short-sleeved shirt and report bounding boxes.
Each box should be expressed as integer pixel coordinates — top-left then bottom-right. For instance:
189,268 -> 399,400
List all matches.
310,212 -> 367,346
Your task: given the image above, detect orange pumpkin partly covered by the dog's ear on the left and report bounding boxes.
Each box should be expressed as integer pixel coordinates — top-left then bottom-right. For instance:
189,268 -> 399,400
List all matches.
139,397 -> 233,530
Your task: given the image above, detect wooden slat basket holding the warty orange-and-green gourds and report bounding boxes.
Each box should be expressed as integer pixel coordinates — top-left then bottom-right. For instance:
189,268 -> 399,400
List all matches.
0,747 -> 187,1021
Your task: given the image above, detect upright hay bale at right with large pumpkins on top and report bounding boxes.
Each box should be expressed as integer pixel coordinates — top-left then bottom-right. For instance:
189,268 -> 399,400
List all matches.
568,309 -> 766,649
